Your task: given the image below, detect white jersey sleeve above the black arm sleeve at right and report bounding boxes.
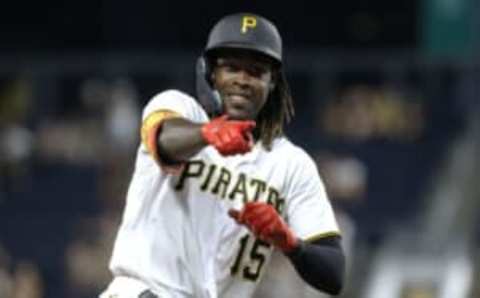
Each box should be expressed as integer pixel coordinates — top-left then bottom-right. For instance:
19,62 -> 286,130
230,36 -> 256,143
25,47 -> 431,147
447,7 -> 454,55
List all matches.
286,148 -> 340,241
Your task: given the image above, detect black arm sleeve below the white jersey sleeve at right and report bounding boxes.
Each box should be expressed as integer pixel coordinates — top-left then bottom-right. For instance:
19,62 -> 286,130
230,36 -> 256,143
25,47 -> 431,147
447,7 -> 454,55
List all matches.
287,236 -> 345,295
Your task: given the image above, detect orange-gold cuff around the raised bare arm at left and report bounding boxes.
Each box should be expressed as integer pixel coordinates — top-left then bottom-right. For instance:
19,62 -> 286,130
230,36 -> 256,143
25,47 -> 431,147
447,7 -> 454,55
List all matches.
140,109 -> 182,174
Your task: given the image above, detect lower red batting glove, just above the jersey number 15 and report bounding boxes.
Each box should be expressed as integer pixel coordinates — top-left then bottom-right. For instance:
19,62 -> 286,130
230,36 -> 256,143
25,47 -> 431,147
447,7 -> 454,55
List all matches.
228,202 -> 298,253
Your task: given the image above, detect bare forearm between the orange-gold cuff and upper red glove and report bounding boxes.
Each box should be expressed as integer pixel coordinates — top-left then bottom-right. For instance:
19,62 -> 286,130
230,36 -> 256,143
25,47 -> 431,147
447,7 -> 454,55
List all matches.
157,118 -> 207,161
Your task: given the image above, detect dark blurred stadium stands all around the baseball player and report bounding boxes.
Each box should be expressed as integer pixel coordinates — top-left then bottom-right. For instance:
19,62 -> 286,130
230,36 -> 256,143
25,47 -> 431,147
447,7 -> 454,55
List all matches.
0,0 -> 480,298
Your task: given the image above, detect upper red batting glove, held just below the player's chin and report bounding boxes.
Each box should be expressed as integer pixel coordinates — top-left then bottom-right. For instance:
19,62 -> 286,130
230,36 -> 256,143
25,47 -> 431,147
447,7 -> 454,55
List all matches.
201,115 -> 255,156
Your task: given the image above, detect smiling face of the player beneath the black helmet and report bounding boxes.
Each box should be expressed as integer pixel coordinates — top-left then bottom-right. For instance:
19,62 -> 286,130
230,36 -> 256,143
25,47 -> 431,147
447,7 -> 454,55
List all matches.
212,53 -> 273,120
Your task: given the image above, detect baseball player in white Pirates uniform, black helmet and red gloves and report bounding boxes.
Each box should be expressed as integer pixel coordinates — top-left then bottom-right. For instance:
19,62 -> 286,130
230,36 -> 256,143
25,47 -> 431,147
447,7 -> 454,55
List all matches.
101,14 -> 344,298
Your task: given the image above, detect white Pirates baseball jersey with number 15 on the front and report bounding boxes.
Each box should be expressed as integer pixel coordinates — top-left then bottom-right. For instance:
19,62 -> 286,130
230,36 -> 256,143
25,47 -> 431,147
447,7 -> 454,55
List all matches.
110,90 -> 339,297
